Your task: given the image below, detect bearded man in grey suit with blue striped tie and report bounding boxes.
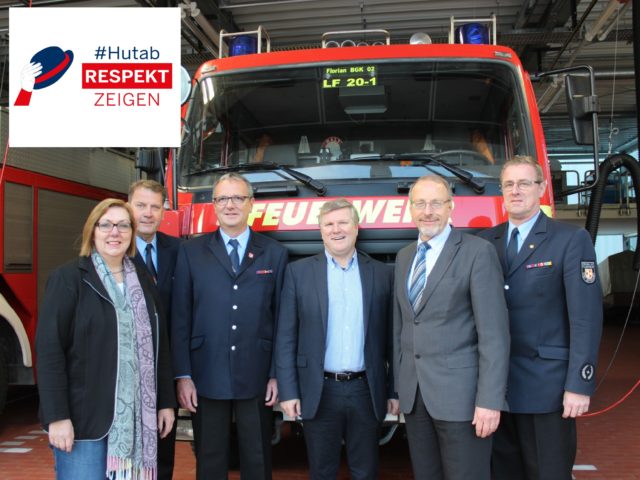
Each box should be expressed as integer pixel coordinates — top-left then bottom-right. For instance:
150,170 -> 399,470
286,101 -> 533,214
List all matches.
393,175 -> 509,480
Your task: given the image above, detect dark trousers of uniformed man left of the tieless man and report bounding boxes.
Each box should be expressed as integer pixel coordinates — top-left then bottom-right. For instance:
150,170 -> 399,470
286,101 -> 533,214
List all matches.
193,396 -> 273,480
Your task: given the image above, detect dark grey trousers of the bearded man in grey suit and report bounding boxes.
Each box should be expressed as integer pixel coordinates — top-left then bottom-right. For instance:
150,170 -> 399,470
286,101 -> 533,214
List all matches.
404,388 -> 491,480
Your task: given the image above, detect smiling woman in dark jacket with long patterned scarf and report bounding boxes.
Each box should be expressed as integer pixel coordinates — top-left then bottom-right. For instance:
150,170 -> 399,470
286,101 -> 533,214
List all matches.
36,199 -> 176,480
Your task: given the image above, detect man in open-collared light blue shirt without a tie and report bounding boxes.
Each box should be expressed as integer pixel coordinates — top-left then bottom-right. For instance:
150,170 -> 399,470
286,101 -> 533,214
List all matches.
276,199 -> 398,480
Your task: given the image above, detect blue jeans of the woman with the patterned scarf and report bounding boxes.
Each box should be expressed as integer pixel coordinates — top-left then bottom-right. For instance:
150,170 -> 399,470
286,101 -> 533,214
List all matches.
53,438 -> 107,480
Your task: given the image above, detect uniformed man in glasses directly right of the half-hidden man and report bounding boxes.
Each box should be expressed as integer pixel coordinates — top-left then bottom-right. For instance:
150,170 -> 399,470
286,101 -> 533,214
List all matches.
171,173 -> 287,480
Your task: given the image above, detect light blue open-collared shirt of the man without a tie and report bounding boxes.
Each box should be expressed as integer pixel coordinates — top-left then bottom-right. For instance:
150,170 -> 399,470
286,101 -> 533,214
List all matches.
324,251 -> 365,372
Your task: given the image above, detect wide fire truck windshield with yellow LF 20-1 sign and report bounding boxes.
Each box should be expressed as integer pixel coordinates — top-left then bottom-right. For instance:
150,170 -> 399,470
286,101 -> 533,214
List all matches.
178,59 -> 536,190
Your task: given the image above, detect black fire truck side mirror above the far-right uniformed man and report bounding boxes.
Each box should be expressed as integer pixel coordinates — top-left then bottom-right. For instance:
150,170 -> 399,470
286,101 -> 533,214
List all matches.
566,75 -> 600,145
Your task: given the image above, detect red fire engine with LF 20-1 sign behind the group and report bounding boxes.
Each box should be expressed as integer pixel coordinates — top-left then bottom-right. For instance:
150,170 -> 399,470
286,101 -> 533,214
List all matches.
159,17 -> 597,442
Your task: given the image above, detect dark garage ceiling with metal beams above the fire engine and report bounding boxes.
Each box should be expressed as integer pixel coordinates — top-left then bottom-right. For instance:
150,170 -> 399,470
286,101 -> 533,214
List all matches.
0,0 -> 638,154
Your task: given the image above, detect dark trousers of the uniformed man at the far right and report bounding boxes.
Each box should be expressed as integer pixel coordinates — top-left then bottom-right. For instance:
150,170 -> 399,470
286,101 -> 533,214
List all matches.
491,412 -> 577,480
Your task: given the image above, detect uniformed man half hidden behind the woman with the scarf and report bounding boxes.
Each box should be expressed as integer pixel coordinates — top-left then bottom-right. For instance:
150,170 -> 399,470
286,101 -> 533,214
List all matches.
129,180 -> 181,480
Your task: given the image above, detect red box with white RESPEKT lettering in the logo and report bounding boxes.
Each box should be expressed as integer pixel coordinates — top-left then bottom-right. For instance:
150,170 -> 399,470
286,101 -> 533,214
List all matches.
82,63 -> 173,88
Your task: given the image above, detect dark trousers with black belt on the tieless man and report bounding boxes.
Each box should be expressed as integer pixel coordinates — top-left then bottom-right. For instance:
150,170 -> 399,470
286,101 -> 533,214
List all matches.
302,378 -> 380,480
